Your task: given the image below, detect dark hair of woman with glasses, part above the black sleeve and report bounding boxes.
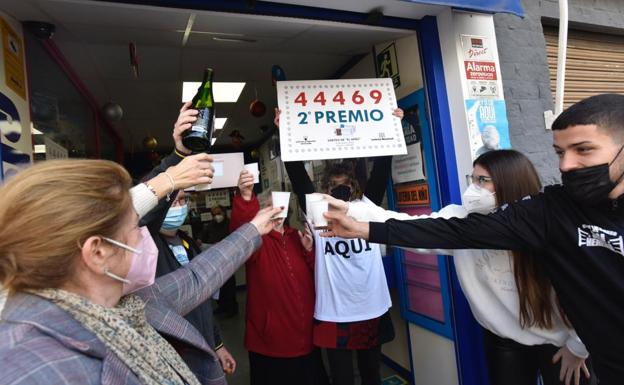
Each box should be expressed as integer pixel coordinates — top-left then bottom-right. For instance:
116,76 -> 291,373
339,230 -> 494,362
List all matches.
473,150 -> 542,206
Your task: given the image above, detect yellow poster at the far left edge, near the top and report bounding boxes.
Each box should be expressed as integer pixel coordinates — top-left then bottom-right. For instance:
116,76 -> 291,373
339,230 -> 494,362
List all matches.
0,19 -> 26,100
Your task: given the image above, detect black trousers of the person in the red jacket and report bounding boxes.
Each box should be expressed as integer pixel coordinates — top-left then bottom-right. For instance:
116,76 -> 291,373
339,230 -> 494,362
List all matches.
249,349 -> 329,385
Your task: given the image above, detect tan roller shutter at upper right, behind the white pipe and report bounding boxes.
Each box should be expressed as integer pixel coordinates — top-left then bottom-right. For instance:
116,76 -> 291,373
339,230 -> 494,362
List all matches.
544,26 -> 624,108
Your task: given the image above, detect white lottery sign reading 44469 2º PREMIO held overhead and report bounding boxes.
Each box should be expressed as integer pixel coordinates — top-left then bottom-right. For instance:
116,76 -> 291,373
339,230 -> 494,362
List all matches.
277,78 -> 407,162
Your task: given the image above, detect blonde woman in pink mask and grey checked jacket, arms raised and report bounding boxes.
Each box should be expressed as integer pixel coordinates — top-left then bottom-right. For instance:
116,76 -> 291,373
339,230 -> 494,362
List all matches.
0,154 -> 280,385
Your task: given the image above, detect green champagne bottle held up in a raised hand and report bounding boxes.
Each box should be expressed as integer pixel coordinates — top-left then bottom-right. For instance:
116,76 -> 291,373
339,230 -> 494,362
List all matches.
182,68 -> 214,153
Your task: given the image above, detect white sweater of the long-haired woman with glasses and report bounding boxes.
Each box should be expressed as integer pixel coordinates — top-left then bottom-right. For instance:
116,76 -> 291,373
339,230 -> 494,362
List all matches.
347,202 -> 589,358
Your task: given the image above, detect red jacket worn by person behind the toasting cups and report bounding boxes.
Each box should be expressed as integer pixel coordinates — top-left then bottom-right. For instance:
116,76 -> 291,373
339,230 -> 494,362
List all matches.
230,194 -> 315,357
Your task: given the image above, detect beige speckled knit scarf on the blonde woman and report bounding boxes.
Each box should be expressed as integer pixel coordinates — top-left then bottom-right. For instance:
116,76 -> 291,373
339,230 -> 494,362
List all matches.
32,289 -> 200,385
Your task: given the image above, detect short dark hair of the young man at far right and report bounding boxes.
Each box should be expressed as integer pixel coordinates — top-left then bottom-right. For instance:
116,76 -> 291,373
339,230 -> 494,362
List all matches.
552,94 -> 624,140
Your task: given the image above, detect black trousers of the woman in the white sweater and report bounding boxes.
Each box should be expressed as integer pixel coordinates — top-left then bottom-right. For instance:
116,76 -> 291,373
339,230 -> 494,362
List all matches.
484,330 -> 596,385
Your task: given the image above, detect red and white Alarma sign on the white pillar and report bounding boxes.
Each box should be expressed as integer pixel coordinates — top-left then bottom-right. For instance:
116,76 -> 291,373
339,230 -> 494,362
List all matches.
461,35 -> 500,98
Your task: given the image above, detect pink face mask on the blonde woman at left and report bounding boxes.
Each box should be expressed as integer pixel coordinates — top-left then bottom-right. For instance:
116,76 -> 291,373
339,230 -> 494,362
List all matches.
103,226 -> 158,295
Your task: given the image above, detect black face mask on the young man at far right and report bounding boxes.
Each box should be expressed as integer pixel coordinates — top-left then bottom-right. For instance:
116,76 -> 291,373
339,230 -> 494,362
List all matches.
561,146 -> 624,206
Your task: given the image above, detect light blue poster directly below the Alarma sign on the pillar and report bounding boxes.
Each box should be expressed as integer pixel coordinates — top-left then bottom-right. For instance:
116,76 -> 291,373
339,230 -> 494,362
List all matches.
466,99 -> 511,160
